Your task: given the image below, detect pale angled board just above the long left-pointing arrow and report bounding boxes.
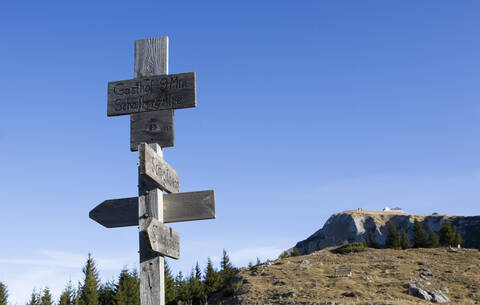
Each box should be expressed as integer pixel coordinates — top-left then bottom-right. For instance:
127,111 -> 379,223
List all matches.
138,143 -> 180,193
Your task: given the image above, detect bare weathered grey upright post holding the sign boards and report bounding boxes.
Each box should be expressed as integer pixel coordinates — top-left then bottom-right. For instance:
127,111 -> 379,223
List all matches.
136,36 -> 173,305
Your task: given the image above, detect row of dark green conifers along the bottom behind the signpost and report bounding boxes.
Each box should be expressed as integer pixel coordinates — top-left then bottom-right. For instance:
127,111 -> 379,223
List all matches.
0,250 -> 238,305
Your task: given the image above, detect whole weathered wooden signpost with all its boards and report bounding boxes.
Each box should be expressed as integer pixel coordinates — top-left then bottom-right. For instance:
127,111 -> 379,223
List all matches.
89,36 -> 215,305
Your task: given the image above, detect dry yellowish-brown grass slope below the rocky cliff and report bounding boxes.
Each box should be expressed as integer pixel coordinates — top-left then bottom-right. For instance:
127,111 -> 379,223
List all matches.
223,248 -> 480,305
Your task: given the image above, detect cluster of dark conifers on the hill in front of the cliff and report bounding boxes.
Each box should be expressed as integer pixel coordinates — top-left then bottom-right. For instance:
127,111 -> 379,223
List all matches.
369,219 -> 463,249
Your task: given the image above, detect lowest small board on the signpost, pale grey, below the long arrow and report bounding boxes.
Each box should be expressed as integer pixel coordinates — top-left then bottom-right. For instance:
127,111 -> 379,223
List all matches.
144,217 -> 180,259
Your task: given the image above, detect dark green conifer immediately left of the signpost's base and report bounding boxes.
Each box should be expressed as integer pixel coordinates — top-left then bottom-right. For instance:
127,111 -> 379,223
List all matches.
115,268 -> 140,305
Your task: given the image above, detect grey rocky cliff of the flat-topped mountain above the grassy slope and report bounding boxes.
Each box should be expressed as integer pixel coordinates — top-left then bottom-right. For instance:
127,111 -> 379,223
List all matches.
294,210 -> 480,254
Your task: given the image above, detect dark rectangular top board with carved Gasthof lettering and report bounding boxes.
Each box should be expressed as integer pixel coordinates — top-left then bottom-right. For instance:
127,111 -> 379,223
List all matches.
107,72 -> 197,116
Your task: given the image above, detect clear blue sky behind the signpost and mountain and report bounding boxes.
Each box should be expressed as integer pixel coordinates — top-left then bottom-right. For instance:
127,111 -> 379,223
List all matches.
0,0 -> 480,305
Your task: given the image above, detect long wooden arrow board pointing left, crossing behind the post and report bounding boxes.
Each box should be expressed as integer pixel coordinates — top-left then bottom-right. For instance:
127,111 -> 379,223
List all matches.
90,190 -> 215,228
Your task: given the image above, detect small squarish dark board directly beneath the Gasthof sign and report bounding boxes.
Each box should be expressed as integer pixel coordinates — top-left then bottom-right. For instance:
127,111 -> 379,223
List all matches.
130,111 -> 174,151
